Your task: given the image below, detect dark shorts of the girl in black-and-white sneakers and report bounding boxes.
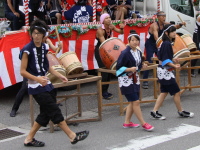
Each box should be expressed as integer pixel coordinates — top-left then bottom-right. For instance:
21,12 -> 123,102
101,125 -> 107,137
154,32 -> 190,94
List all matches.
160,83 -> 180,95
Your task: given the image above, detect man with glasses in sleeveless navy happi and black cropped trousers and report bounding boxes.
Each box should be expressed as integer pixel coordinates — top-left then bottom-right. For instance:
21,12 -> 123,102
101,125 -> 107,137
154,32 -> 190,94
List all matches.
20,20 -> 89,147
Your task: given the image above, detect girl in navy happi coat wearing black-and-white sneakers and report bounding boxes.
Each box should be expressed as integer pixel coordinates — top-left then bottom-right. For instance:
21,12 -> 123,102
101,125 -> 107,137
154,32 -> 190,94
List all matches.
150,24 -> 194,120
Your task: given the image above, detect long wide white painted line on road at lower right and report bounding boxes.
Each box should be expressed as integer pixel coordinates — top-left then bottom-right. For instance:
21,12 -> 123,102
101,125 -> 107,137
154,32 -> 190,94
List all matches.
109,124 -> 200,150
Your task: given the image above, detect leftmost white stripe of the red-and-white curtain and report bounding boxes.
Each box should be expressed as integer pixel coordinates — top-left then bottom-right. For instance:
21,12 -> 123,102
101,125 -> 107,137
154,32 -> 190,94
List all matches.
0,52 -> 12,88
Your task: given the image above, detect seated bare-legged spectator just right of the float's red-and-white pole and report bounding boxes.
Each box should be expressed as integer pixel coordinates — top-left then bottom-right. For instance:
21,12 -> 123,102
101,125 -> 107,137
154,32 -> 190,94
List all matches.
107,0 -> 132,20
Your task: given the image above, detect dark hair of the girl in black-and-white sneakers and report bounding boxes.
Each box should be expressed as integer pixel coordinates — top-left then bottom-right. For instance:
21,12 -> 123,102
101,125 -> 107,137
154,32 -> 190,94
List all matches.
162,24 -> 176,42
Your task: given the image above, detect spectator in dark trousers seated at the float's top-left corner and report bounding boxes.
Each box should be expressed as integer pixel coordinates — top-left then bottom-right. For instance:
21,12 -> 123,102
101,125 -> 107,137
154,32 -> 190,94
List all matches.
5,0 -> 25,30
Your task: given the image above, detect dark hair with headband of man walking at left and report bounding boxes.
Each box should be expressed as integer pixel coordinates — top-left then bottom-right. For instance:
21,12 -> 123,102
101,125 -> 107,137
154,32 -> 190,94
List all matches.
30,19 -> 49,36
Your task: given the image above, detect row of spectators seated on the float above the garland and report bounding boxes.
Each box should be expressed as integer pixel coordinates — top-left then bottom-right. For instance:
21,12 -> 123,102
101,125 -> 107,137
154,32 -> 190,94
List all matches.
5,0 -> 135,30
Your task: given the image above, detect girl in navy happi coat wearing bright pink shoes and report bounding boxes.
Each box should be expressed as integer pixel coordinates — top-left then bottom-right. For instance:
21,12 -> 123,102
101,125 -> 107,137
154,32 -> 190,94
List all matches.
116,30 -> 154,131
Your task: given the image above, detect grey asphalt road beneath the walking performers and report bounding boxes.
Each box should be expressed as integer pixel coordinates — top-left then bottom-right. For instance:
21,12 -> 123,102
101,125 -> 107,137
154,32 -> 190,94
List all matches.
0,72 -> 200,150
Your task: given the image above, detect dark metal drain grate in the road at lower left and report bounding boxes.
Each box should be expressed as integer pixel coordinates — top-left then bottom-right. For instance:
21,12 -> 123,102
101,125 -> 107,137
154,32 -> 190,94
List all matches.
0,129 -> 24,141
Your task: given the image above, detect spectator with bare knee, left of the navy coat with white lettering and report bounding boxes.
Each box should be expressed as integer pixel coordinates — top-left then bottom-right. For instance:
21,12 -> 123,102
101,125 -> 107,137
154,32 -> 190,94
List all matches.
46,0 -> 62,24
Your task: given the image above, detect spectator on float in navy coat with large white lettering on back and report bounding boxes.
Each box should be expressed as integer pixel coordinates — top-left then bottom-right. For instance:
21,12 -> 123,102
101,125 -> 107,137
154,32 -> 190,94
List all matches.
64,0 -> 93,23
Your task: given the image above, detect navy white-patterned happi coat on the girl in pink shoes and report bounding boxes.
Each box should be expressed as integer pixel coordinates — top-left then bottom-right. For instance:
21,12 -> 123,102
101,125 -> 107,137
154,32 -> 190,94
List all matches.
116,46 -> 142,95
